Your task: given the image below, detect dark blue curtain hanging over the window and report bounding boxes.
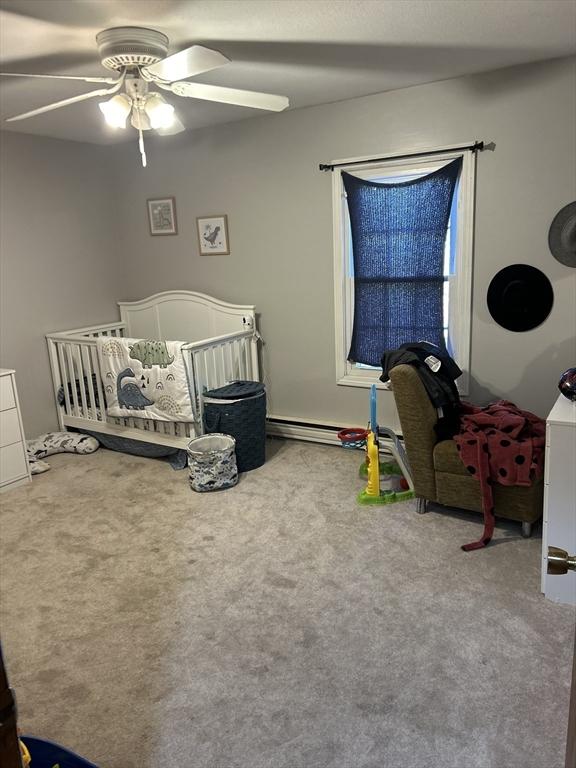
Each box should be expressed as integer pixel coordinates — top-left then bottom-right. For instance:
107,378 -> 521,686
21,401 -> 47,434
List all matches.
342,158 -> 462,366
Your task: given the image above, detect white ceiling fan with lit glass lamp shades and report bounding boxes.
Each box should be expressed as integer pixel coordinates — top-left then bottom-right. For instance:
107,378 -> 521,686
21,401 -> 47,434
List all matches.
0,27 -> 289,167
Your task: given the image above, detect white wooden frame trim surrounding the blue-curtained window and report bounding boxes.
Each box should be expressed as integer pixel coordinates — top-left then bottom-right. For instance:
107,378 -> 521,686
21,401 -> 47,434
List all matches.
332,142 -> 476,395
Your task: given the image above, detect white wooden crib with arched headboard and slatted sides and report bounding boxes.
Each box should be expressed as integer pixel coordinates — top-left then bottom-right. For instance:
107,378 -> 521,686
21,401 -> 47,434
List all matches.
46,291 -> 260,448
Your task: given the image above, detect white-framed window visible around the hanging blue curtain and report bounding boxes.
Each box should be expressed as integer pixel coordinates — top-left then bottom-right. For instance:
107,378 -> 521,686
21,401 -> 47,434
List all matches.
333,151 -> 475,394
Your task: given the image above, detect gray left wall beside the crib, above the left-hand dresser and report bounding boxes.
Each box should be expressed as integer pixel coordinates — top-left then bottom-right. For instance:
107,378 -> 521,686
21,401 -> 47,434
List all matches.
0,132 -> 122,438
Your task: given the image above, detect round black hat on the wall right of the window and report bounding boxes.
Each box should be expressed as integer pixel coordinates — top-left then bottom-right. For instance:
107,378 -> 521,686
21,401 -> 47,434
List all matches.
487,264 -> 554,331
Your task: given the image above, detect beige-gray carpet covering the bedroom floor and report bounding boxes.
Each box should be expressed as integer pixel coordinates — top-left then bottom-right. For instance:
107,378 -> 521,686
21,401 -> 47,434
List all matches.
0,441 -> 573,768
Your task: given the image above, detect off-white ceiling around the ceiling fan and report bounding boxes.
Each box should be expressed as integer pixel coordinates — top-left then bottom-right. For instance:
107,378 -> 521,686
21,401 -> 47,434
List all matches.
0,0 -> 576,143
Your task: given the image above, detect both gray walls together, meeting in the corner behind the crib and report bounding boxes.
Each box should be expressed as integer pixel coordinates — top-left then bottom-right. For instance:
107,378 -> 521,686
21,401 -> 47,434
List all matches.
0,59 -> 576,436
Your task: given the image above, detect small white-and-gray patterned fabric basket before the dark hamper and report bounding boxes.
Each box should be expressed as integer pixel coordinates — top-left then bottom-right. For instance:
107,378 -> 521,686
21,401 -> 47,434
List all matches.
188,433 -> 238,493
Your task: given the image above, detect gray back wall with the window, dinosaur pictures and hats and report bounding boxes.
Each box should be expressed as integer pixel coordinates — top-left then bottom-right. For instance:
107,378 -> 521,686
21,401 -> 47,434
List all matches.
114,59 -> 576,425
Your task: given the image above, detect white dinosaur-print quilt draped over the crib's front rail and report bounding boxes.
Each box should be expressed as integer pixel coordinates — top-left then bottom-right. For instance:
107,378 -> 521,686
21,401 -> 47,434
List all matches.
96,337 -> 194,422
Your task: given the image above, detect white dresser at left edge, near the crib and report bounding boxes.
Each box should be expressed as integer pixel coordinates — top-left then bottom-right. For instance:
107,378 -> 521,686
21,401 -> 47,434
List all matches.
0,368 -> 31,491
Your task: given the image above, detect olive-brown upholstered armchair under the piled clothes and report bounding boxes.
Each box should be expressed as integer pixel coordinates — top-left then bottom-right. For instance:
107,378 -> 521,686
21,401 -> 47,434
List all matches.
389,365 -> 544,537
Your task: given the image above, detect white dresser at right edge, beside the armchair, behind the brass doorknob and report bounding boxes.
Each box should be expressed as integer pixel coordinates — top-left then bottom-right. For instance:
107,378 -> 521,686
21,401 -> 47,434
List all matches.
542,395 -> 576,605
